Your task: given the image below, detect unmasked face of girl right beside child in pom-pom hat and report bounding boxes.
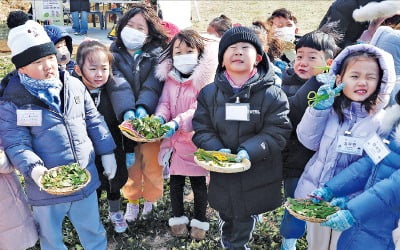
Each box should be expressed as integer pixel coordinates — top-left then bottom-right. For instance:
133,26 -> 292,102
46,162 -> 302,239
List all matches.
76,51 -> 110,90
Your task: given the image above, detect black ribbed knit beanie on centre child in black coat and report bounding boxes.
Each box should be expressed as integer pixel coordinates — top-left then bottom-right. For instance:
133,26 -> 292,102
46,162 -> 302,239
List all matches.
218,26 -> 264,66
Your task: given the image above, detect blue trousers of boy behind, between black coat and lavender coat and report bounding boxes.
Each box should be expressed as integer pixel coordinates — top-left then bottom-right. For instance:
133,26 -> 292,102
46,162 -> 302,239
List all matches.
280,178 -> 306,239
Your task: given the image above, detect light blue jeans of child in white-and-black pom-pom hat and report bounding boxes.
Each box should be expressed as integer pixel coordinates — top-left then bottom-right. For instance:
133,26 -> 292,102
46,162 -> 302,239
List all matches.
33,192 -> 107,250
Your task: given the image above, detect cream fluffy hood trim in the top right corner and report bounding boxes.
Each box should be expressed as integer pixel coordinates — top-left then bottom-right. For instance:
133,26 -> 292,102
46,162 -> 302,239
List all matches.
353,0 -> 400,22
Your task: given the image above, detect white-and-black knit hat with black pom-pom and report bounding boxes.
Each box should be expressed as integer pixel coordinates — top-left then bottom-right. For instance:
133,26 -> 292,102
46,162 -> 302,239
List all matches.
7,11 -> 57,69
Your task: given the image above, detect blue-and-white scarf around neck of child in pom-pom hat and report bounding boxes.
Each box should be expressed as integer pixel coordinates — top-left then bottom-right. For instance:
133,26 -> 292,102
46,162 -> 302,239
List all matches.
18,72 -> 63,113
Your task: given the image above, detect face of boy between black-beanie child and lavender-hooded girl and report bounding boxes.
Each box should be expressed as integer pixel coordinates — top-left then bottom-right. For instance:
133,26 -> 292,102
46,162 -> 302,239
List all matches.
293,47 -> 330,80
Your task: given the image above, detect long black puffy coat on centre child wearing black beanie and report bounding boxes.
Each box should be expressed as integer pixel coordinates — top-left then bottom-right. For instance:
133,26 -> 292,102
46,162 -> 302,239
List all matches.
193,64 -> 291,218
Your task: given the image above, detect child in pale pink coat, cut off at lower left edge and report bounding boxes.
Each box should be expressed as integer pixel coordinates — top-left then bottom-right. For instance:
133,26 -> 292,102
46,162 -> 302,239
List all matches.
0,147 -> 38,250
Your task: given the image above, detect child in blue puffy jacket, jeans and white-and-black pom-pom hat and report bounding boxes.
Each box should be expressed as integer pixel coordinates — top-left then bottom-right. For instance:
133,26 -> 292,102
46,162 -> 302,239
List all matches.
0,11 -> 117,249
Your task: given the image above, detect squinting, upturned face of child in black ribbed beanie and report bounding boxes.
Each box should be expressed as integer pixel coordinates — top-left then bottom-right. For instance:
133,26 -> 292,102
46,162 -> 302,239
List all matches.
222,42 -> 262,74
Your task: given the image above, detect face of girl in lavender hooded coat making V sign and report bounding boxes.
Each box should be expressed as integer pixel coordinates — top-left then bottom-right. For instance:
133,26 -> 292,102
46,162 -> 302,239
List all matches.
336,58 -> 380,102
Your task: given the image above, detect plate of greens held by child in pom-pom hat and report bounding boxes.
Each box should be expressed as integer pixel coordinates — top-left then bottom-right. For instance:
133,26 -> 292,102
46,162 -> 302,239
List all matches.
39,163 -> 91,195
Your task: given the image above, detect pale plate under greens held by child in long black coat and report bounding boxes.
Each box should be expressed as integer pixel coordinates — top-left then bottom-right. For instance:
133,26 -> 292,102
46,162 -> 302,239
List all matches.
194,151 -> 251,173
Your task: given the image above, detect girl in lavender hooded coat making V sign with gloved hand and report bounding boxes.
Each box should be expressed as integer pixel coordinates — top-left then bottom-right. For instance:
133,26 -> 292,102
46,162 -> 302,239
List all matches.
295,44 -> 395,250
